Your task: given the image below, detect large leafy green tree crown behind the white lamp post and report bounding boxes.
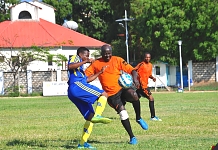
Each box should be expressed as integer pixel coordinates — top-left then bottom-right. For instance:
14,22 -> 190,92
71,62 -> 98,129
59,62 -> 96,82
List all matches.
131,0 -> 218,64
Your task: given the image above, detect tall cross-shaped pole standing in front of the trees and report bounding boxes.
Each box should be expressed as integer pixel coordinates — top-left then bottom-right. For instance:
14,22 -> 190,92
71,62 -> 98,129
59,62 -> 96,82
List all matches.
116,10 -> 134,63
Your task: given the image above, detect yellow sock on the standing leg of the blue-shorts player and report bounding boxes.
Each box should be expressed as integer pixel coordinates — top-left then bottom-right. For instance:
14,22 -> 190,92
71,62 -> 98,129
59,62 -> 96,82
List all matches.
79,121 -> 93,145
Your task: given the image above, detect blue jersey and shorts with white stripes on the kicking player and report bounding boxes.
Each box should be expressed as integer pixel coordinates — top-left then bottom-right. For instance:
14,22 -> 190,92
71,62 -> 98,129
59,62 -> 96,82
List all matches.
68,55 -> 104,120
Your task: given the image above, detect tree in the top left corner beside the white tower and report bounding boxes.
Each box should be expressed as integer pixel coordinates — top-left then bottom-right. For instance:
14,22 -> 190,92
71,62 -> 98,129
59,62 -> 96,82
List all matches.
0,0 -> 19,22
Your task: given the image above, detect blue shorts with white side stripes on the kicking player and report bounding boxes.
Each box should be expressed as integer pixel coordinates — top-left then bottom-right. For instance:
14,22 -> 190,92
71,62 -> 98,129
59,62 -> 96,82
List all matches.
68,81 -> 104,120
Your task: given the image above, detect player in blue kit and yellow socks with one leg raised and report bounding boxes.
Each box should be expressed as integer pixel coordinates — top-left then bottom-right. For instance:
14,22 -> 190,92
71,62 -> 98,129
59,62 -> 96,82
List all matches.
68,47 -> 111,149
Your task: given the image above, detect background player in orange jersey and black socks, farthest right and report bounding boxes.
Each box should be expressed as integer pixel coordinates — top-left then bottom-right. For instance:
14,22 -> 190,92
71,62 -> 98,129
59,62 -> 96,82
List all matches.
135,53 -> 162,121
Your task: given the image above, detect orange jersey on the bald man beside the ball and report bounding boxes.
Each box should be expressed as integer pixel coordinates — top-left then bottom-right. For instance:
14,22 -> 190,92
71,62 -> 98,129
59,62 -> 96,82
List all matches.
85,56 -> 134,96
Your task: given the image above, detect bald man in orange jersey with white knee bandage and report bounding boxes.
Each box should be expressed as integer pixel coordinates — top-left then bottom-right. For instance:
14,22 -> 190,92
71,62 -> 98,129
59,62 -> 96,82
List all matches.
85,45 -> 148,145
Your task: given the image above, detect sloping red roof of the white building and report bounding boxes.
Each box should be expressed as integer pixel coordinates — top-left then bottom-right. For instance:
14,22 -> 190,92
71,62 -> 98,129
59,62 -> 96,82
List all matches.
0,19 -> 105,48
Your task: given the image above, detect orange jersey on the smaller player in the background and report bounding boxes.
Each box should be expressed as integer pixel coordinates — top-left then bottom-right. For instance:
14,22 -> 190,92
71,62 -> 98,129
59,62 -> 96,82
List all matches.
135,62 -> 152,89
